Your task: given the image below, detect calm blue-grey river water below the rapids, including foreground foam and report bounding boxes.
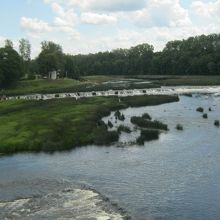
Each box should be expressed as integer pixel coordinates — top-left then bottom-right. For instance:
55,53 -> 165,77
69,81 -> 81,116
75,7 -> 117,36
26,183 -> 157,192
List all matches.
0,95 -> 220,220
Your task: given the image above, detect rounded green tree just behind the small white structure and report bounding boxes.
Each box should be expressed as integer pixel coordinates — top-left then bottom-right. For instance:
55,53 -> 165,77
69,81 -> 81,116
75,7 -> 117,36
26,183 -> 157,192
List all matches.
37,41 -> 63,75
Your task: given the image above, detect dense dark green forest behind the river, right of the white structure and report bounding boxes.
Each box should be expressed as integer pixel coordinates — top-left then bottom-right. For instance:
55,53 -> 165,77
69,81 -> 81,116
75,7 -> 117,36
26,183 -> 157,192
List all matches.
60,34 -> 220,75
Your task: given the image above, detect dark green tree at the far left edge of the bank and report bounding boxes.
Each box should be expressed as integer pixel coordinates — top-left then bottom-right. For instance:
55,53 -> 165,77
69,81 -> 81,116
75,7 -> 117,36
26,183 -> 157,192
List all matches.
0,46 -> 23,88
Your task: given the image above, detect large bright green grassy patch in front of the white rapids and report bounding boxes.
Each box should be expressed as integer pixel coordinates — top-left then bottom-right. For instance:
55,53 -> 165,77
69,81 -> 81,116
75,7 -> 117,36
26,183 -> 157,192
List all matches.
0,96 -> 178,153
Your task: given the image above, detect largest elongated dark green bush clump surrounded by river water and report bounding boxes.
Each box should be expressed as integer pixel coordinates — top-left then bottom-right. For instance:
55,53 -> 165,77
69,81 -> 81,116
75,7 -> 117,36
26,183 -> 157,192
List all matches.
131,116 -> 168,131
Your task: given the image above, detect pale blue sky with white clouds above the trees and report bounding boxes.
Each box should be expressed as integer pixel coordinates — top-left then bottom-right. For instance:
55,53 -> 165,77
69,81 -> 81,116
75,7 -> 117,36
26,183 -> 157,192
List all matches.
0,0 -> 220,57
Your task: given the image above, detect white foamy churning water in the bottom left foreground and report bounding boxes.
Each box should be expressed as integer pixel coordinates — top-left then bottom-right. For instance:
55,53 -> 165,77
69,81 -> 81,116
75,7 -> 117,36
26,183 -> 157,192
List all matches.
0,189 -> 124,220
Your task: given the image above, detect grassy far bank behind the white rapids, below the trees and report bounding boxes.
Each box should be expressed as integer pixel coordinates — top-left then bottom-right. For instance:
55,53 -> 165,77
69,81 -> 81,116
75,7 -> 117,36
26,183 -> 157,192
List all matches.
0,76 -> 158,96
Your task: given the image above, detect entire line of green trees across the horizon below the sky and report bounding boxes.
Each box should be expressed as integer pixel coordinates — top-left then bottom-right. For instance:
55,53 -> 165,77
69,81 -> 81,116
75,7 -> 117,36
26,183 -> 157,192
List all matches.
0,34 -> 220,87
